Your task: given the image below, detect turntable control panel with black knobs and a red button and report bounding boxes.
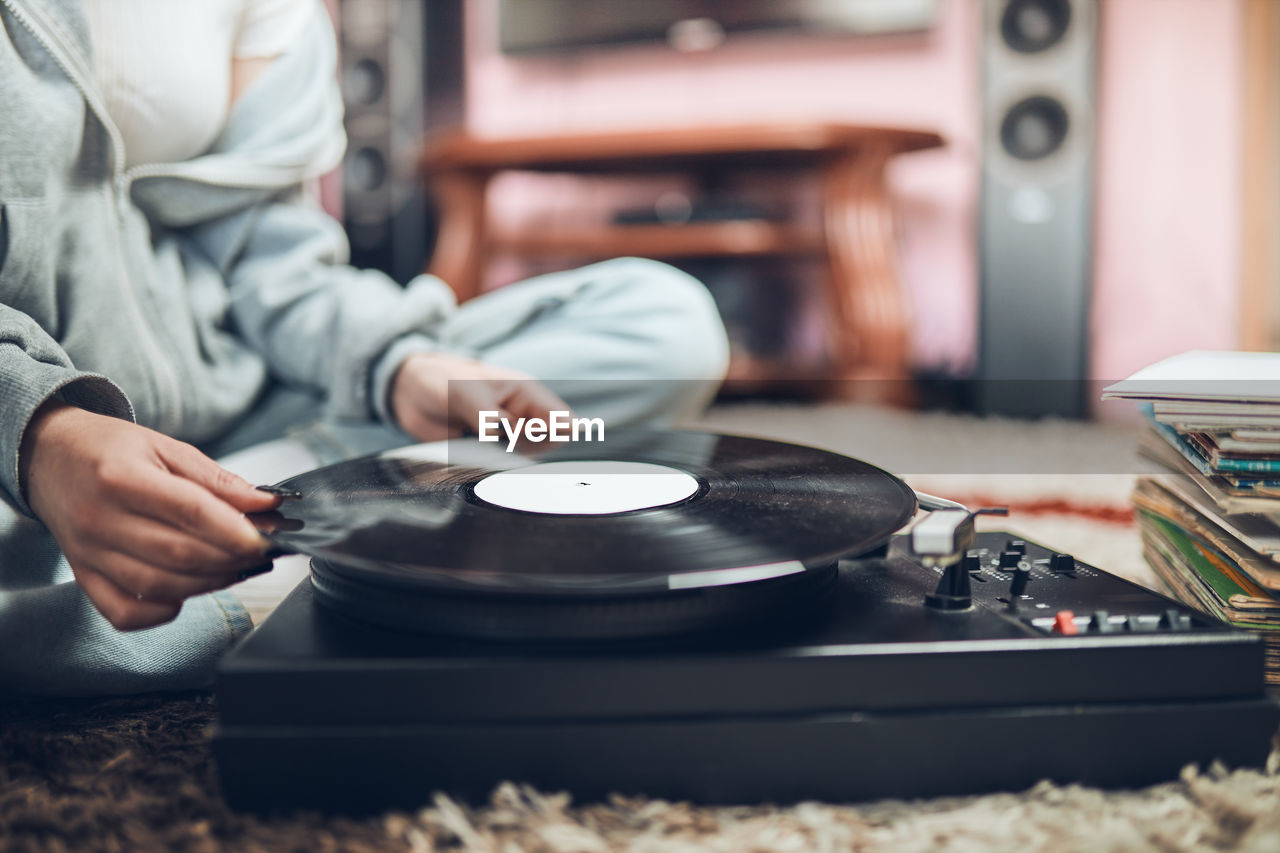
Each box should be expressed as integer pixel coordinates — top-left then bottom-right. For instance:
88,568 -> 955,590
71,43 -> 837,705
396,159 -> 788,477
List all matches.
925,532 -> 1217,637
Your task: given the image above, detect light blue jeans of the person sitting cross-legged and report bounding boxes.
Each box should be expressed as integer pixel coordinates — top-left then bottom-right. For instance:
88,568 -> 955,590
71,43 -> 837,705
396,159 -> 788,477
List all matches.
0,259 -> 728,695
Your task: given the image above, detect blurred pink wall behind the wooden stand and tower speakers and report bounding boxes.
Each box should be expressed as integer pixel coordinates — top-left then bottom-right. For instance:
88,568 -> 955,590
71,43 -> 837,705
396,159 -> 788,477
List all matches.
467,0 -> 1240,378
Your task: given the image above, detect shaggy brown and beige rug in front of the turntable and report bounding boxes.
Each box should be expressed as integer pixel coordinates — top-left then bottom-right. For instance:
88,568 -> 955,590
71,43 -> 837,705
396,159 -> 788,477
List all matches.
0,694 -> 1280,853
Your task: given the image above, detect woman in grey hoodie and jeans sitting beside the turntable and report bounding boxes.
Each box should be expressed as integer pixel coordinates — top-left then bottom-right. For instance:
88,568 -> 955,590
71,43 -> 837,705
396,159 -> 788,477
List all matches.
0,0 -> 726,694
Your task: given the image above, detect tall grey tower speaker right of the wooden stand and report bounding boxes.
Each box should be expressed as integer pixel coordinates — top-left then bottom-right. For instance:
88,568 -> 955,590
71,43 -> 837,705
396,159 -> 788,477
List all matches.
977,0 -> 1097,418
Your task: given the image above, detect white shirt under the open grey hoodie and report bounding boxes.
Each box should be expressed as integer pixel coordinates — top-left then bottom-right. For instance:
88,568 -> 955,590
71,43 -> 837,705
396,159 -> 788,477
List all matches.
86,0 -> 316,168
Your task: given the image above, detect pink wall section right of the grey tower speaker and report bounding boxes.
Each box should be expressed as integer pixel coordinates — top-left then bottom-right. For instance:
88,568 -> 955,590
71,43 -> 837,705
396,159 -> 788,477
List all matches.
1093,0 -> 1239,379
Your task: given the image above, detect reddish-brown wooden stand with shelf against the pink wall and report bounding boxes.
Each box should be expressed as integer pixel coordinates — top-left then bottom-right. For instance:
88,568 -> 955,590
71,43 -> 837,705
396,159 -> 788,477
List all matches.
422,124 -> 942,389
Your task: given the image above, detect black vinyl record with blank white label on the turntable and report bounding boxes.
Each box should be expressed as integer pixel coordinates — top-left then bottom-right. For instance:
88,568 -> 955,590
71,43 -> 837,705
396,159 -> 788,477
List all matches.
257,429 -> 915,599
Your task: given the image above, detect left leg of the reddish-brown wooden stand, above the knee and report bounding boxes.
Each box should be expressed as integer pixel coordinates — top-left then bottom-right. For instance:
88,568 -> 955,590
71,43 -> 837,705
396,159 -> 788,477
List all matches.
428,170 -> 489,302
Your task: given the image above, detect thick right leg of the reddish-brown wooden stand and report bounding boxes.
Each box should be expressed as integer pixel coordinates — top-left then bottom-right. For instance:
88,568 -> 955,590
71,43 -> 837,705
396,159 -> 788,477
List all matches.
823,146 -> 910,396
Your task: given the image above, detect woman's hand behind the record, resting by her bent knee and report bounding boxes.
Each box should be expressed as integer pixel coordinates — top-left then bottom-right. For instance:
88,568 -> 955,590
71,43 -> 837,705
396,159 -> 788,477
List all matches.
390,352 -> 568,442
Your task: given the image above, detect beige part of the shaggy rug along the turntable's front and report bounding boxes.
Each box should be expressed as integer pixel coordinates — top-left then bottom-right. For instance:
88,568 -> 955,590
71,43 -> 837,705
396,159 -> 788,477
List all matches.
394,754 -> 1280,853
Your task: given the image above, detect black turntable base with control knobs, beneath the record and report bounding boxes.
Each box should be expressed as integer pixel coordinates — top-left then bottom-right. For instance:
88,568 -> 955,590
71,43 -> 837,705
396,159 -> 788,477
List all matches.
214,533 -> 1280,812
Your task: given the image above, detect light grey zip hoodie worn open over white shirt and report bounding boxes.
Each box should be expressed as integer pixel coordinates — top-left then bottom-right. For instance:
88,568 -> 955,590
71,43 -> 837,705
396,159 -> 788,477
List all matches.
0,0 -> 453,512
